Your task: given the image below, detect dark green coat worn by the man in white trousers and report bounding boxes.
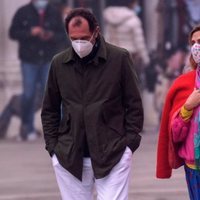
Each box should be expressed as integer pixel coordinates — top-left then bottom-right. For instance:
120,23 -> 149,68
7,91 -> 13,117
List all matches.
41,37 -> 143,180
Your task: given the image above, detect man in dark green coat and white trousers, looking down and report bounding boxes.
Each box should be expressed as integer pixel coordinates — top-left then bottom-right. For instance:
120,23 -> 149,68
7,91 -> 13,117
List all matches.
41,8 -> 143,200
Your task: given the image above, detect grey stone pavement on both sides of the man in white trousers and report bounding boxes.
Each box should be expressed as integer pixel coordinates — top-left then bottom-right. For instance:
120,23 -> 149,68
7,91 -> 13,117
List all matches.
0,126 -> 188,200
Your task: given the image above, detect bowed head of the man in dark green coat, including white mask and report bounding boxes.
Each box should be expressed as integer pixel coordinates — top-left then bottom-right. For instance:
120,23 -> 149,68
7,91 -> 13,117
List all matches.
65,8 -> 99,58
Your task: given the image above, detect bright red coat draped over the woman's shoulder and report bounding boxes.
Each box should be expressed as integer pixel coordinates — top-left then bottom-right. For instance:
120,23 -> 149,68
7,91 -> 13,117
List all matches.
156,70 -> 196,178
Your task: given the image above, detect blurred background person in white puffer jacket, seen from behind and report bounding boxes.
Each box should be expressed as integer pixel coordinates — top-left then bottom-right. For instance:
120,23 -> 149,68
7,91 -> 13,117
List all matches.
103,0 -> 150,90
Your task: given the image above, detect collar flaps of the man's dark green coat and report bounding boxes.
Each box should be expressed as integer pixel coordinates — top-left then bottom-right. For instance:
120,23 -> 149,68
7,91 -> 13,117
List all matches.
63,35 -> 107,65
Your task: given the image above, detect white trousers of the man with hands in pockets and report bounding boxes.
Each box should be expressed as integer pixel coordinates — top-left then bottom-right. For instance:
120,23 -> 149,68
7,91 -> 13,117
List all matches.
52,147 -> 132,200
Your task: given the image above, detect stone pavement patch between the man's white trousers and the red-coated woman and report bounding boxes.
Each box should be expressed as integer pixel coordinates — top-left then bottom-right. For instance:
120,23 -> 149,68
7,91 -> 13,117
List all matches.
129,127 -> 189,200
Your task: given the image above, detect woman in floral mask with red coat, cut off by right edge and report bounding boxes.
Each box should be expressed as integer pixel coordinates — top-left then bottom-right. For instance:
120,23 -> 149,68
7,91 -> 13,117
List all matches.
156,26 -> 200,200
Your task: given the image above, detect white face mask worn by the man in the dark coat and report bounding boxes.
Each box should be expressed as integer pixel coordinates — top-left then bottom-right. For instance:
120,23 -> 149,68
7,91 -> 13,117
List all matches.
72,40 -> 93,58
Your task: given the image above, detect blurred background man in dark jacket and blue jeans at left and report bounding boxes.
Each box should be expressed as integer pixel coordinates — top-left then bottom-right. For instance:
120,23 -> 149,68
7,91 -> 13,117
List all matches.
9,0 -> 65,140
